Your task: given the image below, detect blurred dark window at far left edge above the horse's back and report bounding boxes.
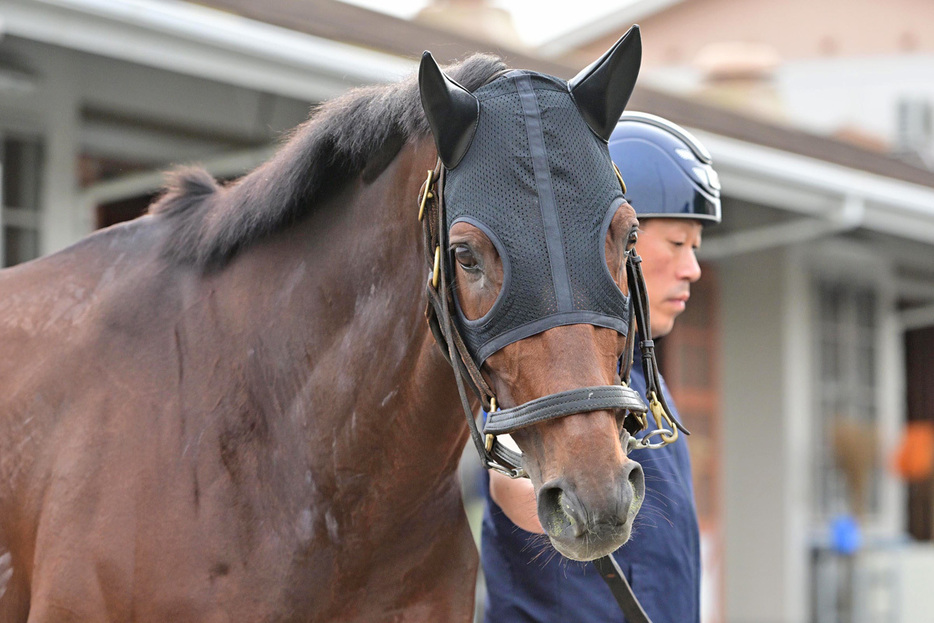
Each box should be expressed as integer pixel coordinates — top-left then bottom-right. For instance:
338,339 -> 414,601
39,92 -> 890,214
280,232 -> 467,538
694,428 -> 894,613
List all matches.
0,136 -> 42,266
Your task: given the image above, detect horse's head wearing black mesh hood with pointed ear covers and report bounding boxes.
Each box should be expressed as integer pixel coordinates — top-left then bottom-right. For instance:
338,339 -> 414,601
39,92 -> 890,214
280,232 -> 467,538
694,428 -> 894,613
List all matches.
419,27 -> 645,560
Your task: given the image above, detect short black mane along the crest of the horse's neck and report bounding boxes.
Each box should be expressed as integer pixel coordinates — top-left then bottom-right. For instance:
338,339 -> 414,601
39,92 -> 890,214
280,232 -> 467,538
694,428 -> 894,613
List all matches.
149,54 -> 505,268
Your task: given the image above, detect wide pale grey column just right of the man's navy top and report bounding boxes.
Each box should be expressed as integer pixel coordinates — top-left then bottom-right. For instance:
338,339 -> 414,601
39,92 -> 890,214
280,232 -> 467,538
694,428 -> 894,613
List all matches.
720,250 -> 805,623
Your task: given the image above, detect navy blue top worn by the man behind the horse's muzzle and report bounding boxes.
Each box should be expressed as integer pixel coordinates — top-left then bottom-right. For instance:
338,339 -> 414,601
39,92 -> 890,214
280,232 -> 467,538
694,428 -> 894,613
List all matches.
481,349 -> 700,623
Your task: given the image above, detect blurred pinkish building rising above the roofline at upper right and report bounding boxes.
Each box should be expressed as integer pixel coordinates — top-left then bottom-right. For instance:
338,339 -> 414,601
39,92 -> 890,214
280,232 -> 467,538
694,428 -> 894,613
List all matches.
539,0 -> 934,168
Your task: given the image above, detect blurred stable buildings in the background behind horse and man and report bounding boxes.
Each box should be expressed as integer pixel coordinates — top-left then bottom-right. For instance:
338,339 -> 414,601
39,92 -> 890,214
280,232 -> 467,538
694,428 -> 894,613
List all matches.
0,0 -> 934,623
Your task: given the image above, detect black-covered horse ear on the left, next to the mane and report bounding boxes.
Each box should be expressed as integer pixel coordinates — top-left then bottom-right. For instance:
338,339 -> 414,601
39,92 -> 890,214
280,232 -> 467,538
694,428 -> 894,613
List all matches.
418,52 -> 480,169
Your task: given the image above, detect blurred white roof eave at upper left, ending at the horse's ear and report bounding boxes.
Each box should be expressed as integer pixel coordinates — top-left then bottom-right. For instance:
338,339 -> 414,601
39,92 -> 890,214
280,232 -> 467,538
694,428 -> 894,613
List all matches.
2,0 -> 415,102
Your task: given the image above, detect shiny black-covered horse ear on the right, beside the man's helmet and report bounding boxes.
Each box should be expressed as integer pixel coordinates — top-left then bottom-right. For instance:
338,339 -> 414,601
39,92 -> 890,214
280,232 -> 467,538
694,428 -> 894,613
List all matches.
568,25 -> 642,141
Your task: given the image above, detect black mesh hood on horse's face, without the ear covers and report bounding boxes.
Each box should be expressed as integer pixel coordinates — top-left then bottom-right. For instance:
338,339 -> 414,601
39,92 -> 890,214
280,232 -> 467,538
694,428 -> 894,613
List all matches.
444,71 -> 629,364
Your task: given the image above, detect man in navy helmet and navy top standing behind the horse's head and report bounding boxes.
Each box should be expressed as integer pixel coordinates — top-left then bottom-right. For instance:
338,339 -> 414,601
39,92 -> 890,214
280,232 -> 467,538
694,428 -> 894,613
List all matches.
481,113 -> 720,623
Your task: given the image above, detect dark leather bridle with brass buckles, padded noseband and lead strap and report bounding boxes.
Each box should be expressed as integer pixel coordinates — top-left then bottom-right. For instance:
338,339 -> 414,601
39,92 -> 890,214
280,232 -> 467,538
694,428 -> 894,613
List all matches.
418,158 -> 690,623
